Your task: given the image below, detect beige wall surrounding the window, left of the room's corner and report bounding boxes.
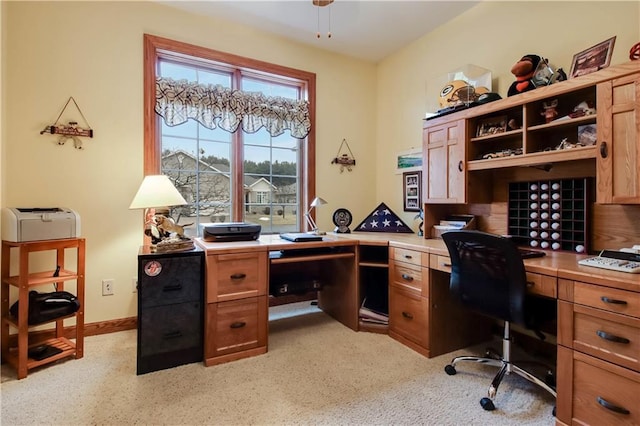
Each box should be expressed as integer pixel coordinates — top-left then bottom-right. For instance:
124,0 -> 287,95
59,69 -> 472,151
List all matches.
2,2 -> 376,323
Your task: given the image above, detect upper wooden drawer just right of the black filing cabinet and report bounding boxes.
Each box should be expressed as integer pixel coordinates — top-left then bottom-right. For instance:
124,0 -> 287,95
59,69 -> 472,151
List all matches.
207,252 -> 268,303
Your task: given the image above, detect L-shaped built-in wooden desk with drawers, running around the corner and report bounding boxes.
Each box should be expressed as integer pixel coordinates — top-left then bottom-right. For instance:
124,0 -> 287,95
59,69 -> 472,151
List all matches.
197,232 -> 640,424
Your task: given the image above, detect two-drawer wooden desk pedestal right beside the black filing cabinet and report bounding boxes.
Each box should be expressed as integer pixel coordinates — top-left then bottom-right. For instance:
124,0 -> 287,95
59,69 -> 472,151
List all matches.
204,248 -> 268,366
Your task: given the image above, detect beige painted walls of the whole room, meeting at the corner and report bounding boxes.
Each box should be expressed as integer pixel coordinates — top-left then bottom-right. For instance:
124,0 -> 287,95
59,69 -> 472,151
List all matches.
0,2 -> 640,323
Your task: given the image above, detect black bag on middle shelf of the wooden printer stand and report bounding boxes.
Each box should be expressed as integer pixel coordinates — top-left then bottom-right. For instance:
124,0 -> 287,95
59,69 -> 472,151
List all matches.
9,290 -> 80,325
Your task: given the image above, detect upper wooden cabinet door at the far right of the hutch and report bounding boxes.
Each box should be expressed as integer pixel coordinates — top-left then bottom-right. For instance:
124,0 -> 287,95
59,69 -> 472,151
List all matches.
596,73 -> 640,204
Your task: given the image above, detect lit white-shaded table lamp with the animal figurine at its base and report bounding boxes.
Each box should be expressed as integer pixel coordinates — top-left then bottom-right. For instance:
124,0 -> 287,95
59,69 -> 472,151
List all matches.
129,175 -> 194,252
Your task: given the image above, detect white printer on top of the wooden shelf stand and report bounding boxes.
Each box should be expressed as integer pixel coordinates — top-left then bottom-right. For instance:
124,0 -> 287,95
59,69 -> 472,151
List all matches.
2,207 -> 80,242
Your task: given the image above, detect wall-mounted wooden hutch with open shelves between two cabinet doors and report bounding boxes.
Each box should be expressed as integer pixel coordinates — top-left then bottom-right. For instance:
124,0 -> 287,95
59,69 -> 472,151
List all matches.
423,61 -> 640,204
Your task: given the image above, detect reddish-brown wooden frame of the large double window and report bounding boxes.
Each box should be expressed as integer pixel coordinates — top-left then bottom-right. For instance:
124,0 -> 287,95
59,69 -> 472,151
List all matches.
143,34 -> 316,226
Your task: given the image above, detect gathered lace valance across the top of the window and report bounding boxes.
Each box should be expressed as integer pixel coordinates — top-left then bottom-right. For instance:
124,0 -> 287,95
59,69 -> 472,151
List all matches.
155,77 -> 311,139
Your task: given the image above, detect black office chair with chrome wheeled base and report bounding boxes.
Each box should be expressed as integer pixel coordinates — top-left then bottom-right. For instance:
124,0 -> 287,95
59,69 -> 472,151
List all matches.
442,230 -> 556,415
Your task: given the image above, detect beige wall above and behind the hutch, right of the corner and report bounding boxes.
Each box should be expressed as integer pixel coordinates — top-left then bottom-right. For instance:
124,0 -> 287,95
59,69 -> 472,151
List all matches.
376,1 -> 640,218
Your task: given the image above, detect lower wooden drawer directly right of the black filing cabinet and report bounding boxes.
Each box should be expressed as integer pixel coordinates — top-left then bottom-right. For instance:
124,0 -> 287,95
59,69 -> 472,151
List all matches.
205,296 -> 268,358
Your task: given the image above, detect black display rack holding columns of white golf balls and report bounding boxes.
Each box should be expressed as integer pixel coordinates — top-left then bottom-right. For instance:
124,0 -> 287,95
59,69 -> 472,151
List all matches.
509,178 -> 593,253
